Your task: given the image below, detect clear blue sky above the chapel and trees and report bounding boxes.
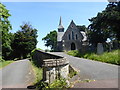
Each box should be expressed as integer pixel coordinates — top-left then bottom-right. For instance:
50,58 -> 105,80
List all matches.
3,2 -> 108,50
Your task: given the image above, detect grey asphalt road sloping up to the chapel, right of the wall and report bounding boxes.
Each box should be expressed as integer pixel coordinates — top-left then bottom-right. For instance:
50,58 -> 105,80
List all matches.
52,52 -> 120,88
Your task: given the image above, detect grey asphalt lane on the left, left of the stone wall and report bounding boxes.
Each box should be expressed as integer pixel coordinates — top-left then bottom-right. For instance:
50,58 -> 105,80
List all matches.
0,59 -> 34,88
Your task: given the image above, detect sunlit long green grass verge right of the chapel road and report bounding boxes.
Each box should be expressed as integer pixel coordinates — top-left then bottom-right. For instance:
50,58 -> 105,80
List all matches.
67,50 -> 120,65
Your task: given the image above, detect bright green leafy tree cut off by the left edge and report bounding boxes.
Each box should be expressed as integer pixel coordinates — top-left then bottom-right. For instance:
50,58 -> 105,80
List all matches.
0,3 -> 12,59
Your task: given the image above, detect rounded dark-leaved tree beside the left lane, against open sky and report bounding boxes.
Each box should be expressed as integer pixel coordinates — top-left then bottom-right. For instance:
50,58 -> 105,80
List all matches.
12,23 -> 38,59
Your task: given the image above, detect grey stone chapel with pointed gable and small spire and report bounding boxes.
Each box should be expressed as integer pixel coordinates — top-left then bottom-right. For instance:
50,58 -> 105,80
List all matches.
57,17 -> 87,51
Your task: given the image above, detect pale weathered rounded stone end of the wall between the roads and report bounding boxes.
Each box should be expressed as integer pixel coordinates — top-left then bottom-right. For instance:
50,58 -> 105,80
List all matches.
43,58 -> 69,83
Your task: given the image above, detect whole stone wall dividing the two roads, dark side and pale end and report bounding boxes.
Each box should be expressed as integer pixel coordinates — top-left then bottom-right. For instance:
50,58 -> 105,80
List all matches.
33,50 -> 69,83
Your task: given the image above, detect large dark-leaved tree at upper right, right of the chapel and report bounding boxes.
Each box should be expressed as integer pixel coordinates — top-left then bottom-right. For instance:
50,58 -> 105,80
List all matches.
88,2 -> 120,47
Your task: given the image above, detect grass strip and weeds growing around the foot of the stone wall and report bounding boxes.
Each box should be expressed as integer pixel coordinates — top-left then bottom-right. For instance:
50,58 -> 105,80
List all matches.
31,61 -> 67,90
